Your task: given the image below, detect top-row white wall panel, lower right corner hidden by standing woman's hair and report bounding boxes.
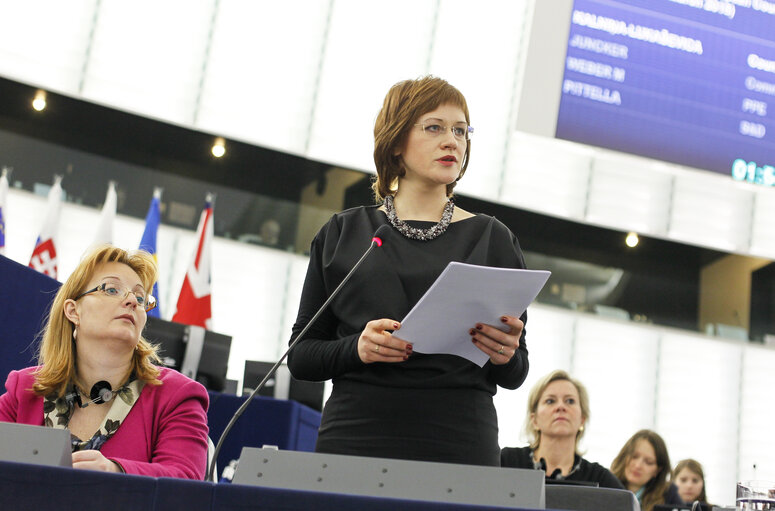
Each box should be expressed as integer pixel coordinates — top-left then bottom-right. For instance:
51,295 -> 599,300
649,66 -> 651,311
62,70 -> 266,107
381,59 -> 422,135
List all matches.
307,0 -> 436,170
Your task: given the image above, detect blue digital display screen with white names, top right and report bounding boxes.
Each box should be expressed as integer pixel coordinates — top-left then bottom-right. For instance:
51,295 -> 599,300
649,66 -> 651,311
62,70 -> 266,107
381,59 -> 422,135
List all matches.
555,0 -> 775,186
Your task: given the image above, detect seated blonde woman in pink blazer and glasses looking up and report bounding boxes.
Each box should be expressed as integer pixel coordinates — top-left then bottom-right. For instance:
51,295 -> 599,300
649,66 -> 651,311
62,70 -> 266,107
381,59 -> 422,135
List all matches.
0,245 -> 208,479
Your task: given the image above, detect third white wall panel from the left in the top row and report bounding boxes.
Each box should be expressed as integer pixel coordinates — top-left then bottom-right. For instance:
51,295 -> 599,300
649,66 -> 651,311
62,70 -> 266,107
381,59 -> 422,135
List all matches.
196,0 -> 329,154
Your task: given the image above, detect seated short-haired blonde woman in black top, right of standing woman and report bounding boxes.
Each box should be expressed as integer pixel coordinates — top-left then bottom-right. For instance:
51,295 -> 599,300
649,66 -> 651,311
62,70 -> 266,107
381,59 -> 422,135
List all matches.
501,370 -> 624,489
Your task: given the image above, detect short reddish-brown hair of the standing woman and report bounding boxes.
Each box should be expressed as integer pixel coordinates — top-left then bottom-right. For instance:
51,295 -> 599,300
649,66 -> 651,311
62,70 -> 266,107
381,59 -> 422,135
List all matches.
372,75 -> 471,202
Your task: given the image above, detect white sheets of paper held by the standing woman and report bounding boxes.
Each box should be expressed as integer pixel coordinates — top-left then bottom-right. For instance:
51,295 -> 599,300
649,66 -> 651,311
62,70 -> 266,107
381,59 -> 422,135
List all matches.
395,262 -> 551,367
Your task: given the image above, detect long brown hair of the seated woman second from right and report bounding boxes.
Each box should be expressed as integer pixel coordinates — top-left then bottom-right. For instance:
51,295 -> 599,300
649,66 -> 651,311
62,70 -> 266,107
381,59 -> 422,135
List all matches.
611,429 -> 670,511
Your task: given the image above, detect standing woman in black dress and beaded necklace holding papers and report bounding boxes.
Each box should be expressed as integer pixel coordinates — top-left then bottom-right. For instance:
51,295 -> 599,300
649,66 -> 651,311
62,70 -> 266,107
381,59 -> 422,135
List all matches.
288,77 -> 528,466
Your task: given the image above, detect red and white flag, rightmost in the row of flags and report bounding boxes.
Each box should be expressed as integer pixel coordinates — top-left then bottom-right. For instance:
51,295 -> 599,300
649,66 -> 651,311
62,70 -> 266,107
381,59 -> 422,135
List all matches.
172,193 -> 214,330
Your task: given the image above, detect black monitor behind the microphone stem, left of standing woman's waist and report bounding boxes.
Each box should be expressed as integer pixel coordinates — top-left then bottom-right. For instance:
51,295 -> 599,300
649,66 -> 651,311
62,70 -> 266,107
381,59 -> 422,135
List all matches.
242,360 -> 324,411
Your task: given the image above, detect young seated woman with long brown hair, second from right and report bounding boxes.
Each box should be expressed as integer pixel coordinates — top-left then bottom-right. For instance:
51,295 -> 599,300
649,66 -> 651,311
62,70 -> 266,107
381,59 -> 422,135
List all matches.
611,429 -> 683,511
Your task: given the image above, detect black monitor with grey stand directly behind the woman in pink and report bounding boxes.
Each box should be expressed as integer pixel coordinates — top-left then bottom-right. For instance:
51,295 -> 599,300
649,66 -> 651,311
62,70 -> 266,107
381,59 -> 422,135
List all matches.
143,317 -> 231,392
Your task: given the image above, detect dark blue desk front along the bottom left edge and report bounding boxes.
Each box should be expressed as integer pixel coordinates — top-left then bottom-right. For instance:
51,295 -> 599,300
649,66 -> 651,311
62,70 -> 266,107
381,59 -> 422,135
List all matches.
0,461 -> 540,511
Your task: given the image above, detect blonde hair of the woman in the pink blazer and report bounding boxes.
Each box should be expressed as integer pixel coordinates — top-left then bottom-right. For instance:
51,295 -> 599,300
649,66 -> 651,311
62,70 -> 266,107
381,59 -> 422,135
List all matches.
32,245 -> 161,397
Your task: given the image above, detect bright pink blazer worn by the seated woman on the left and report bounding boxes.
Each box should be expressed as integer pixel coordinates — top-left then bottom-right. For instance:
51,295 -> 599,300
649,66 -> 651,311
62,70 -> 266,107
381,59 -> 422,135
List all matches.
0,367 -> 209,480
